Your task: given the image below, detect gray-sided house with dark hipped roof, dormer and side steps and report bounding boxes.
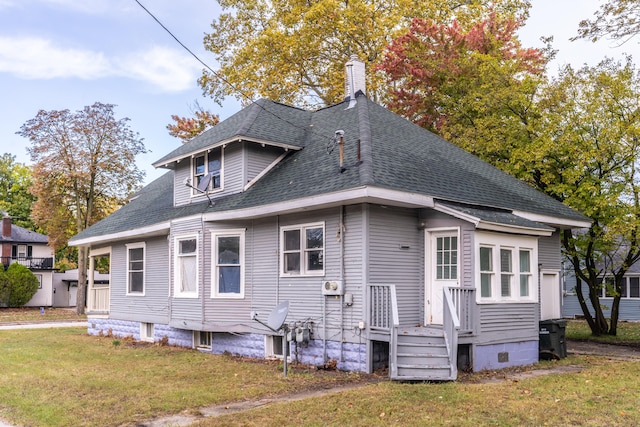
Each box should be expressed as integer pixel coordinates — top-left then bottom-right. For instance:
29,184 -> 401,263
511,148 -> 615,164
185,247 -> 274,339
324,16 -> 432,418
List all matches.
70,60 -> 589,380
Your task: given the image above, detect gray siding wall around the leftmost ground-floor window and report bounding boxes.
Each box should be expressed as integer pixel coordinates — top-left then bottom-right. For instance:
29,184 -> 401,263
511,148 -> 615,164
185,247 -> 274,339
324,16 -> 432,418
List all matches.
109,237 -> 169,324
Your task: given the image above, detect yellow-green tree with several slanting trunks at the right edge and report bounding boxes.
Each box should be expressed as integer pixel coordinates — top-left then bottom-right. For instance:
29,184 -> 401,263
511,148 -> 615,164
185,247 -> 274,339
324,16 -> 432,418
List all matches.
532,58 -> 640,335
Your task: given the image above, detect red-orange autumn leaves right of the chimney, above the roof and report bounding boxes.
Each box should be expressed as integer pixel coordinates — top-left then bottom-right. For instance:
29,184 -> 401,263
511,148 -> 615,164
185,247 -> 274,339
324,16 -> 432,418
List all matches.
378,14 -> 546,132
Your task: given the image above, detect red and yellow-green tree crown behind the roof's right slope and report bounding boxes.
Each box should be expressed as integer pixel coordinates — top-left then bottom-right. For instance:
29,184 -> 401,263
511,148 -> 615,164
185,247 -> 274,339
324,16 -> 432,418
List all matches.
379,13 -> 549,175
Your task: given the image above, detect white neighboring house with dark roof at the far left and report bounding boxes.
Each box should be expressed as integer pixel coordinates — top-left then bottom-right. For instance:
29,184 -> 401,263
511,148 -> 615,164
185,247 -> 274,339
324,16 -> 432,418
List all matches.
0,215 -> 54,307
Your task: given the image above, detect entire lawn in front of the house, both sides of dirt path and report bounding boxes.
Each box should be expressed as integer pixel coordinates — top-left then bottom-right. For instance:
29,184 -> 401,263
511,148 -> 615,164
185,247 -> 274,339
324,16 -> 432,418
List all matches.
0,310 -> 640,427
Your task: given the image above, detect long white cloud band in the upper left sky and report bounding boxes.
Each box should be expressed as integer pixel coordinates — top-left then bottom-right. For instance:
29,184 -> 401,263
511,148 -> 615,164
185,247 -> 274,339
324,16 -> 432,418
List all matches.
0,36 -> 199,92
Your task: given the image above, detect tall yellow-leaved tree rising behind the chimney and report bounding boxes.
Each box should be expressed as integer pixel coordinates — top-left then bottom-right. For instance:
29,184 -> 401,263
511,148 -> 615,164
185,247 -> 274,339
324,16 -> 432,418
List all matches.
199,0 -> 529,107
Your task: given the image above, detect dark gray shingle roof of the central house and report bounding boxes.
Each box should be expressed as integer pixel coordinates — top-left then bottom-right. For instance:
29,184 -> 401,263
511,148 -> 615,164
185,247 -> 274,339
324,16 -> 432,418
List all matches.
72,95 -> 588,246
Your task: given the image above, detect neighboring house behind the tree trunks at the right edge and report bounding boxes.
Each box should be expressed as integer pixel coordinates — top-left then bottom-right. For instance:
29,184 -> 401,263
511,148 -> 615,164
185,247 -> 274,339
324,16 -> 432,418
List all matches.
562,262 -> 640,321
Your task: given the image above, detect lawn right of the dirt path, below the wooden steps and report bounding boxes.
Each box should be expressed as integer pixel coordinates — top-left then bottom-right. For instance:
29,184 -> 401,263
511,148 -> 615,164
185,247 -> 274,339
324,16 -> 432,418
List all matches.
191,358 -> 640,427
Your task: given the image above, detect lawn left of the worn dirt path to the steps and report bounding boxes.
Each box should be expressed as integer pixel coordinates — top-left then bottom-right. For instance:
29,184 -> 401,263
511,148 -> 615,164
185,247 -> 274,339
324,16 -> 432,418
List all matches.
0,328 -> 370,426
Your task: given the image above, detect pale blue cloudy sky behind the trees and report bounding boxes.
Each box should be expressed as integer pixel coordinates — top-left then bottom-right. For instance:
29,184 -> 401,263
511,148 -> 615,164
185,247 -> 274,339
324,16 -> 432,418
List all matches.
0,0 -> 640,183
